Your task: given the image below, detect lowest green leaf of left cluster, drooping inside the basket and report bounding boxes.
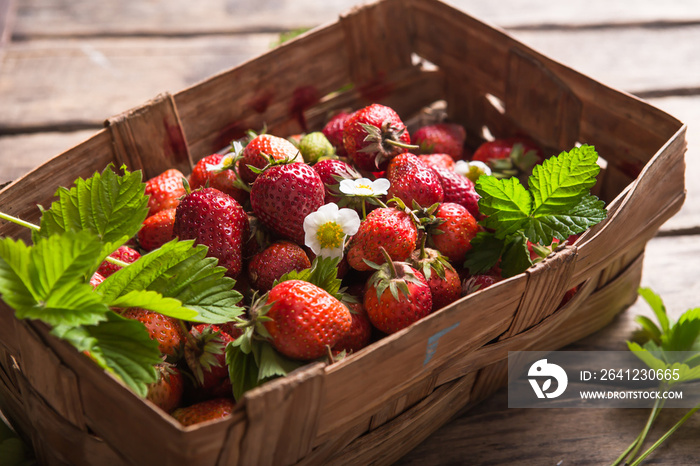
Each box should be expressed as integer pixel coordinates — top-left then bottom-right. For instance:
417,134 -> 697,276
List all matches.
52,312 -> 161,397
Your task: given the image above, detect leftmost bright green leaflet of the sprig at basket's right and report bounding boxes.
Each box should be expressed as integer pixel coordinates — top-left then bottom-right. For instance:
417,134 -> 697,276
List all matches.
475,176 -> 532,239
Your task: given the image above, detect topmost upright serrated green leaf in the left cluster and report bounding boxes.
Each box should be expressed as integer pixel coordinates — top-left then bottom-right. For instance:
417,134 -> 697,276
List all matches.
34,165 -> 148,257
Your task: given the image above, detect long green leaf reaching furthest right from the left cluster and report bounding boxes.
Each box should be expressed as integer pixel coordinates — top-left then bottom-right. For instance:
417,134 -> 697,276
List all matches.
97,240 -> 243,324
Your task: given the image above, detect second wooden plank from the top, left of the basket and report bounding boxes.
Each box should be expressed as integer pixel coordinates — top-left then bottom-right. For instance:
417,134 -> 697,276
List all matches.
0,34 -> 277,134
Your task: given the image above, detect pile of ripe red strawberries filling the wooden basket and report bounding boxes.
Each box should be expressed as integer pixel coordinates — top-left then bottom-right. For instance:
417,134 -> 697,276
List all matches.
102,104 -> 539,425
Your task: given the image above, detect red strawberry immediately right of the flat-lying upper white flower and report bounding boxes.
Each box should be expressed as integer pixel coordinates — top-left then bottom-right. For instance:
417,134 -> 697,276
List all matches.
387,153 -> 443,207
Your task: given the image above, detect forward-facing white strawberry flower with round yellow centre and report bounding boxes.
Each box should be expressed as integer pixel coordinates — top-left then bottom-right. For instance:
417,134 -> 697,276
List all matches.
304,202 -> 360,257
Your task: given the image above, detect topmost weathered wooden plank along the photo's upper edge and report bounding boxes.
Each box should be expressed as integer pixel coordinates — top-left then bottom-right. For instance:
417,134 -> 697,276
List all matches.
9,0 -> 700,39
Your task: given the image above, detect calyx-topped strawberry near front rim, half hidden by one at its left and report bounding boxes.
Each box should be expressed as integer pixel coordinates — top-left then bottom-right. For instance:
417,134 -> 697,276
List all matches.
407,244 -> 462,311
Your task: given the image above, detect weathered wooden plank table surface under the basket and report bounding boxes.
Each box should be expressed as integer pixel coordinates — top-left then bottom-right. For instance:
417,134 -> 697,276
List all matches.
0,0 -> 700,465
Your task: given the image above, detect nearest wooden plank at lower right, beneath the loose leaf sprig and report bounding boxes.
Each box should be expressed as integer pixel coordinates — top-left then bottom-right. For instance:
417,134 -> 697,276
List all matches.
398,236 -> 700,465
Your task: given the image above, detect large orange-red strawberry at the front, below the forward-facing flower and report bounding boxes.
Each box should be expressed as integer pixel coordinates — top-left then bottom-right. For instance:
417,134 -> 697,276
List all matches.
264,280 -> 352,361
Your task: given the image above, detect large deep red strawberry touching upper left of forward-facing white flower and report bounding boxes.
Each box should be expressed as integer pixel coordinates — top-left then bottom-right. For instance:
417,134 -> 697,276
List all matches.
250,163 -> 326,244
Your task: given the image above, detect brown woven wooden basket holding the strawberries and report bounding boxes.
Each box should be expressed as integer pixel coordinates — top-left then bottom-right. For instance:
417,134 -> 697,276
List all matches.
0,0 -> 685,465
